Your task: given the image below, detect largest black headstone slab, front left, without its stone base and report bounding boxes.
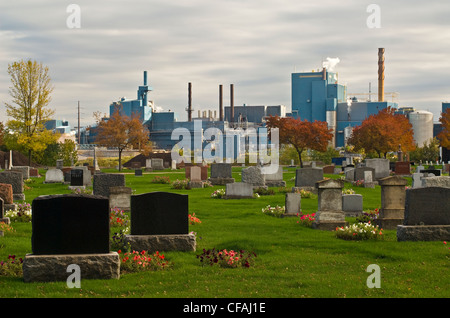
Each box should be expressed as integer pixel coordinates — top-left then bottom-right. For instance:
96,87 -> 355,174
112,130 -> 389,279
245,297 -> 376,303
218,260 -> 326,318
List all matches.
31,194 -> 110,255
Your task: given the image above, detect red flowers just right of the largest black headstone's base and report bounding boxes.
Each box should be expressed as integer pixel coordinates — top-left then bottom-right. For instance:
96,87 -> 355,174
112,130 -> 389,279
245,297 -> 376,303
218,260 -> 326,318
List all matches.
117,250 -> 172,273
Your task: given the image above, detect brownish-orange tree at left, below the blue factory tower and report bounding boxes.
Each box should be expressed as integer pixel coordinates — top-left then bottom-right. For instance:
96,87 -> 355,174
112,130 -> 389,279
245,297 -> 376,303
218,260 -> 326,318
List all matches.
94,107 -> 150,171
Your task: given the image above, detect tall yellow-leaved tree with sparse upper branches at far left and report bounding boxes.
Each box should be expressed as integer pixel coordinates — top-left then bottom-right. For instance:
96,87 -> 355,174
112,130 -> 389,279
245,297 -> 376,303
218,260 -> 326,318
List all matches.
5,60 -> 57,164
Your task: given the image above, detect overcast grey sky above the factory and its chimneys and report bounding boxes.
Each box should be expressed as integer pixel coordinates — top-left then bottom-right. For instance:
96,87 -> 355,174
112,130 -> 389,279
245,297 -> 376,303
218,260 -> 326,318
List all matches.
0,0 -> 450,127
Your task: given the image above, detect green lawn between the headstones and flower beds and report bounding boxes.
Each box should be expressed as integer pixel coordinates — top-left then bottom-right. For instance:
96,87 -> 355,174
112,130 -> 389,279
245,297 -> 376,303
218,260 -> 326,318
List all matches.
0,168 -> 450,298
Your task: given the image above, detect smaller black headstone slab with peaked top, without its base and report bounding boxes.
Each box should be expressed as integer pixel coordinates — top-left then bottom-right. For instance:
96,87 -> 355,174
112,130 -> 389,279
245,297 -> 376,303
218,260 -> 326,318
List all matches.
131,192 -> 189,235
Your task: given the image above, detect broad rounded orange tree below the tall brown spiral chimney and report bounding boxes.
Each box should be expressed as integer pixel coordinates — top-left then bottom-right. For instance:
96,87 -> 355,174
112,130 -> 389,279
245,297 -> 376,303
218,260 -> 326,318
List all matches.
347,107 -> 416,158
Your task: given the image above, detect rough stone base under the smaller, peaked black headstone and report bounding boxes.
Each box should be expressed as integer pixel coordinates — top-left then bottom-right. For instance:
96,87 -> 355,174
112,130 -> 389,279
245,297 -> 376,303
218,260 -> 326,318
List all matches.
124,234 -> 197,252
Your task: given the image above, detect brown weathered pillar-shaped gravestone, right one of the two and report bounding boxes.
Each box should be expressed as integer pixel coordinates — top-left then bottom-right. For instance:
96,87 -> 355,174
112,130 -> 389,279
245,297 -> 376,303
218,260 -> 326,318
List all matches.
376,176 -> 407,230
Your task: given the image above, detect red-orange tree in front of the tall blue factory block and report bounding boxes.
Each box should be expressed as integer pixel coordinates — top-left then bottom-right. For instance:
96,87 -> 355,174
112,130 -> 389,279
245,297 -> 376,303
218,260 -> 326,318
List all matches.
266,116 -> 333,168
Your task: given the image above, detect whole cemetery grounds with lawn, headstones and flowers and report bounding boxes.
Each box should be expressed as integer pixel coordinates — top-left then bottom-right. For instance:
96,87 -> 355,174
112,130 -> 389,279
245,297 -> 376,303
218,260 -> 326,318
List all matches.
0,160 -> 450,298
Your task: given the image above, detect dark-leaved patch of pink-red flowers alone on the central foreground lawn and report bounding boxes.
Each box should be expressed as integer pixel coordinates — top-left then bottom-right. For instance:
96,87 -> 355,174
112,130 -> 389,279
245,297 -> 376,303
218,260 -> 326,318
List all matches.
197,248 -> 256,268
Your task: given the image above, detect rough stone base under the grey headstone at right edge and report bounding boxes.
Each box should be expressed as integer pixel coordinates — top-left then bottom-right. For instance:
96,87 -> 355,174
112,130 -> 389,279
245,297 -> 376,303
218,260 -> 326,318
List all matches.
397,225 -> 450,241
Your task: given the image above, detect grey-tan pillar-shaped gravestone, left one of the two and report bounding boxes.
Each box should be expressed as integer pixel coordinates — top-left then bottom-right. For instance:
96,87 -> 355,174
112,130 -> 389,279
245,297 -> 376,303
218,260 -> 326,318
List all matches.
312,179 -> 345,231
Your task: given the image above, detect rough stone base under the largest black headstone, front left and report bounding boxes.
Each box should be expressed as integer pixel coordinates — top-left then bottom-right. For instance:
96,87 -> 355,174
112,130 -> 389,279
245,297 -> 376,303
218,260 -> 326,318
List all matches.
22,252 -> 120,282
